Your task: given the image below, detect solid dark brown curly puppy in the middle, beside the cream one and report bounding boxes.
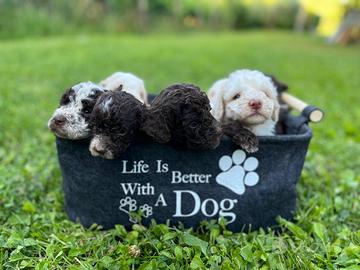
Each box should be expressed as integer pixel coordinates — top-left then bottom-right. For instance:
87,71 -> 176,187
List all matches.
142,84 -> 221,149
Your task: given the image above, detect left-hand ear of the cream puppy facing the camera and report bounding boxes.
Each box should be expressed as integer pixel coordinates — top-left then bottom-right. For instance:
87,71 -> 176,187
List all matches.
208,80 -> 227,121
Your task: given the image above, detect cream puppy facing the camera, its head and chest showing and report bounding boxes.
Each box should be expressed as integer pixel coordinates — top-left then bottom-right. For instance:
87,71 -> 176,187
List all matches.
208,69 -> 280,136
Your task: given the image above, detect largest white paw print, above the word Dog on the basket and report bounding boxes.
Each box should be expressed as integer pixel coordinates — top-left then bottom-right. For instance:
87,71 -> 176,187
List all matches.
216,150 -> 259,195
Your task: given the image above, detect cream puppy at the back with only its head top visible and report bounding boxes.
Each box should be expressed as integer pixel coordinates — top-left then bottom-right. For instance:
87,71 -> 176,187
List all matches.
100,71 -> 148,104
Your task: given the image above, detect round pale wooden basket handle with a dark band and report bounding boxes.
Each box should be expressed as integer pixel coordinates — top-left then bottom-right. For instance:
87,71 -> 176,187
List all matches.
281,92 -> 324,123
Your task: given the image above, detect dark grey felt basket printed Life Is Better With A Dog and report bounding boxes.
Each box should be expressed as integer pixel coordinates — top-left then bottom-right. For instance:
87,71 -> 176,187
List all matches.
56,107 -> 318,231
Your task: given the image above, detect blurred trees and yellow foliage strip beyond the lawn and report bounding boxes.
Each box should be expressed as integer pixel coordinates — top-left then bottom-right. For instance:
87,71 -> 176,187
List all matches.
0,0 -> 360,43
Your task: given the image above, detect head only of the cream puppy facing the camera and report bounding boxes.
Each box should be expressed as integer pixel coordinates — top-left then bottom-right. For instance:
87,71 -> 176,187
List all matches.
215,70 -> 279,125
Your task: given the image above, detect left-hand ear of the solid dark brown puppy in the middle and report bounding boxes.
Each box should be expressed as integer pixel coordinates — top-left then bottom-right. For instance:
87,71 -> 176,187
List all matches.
141,109 -> 171,143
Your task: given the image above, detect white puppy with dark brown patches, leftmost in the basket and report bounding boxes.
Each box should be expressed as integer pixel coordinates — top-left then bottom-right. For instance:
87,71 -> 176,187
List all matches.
48,82 -> 106,140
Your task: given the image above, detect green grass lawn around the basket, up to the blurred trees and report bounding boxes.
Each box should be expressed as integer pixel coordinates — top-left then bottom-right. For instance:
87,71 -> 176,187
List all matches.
0,32 -> 360,269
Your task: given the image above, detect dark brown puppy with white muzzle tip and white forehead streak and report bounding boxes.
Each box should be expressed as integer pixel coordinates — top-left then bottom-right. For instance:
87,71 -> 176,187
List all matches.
89,91 -> 145,159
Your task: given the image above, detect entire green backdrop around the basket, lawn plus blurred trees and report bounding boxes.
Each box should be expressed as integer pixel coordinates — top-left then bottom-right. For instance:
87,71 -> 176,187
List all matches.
0,0 -> 360,270
